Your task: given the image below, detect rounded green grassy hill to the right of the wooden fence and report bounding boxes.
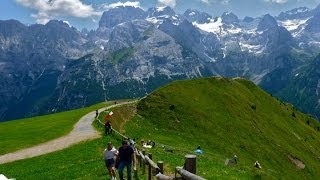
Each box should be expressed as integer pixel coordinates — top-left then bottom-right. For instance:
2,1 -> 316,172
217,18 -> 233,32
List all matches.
126,78 -> 320,179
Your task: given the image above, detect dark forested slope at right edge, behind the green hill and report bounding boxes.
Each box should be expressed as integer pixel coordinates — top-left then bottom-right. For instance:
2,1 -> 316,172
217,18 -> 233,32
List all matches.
260,55 -> 320,120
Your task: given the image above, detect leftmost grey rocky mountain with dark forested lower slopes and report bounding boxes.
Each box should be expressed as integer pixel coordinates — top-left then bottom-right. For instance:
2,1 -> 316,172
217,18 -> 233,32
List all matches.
0,20 -> 85,119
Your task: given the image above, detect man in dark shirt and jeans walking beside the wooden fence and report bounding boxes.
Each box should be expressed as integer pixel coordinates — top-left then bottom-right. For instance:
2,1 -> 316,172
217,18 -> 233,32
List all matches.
117,140 -> 136,180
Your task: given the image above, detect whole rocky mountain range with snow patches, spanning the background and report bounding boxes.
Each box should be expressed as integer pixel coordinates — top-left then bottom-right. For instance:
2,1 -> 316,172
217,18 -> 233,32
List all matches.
0,4 -> 320,119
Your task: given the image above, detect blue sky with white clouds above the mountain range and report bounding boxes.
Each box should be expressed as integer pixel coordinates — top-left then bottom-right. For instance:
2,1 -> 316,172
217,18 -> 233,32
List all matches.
0,0 -> 320,29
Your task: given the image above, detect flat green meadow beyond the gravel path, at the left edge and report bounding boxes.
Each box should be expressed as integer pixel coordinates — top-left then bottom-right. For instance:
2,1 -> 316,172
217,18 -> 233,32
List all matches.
0,102 -> 112,155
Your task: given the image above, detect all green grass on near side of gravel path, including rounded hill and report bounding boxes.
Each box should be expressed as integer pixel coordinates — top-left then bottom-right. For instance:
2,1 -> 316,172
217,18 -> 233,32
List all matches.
0,78 -> 320,179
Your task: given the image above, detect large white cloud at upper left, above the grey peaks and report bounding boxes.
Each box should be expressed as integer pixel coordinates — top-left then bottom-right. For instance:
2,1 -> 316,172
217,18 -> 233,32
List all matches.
16,0 -> 101,24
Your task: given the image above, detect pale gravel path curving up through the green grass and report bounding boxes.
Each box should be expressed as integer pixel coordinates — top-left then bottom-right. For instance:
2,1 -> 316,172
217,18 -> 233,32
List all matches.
0,101 -> 136,164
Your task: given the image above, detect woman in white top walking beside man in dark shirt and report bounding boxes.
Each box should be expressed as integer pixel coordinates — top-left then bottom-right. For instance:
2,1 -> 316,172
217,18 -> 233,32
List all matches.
103,142 -> 118,180
